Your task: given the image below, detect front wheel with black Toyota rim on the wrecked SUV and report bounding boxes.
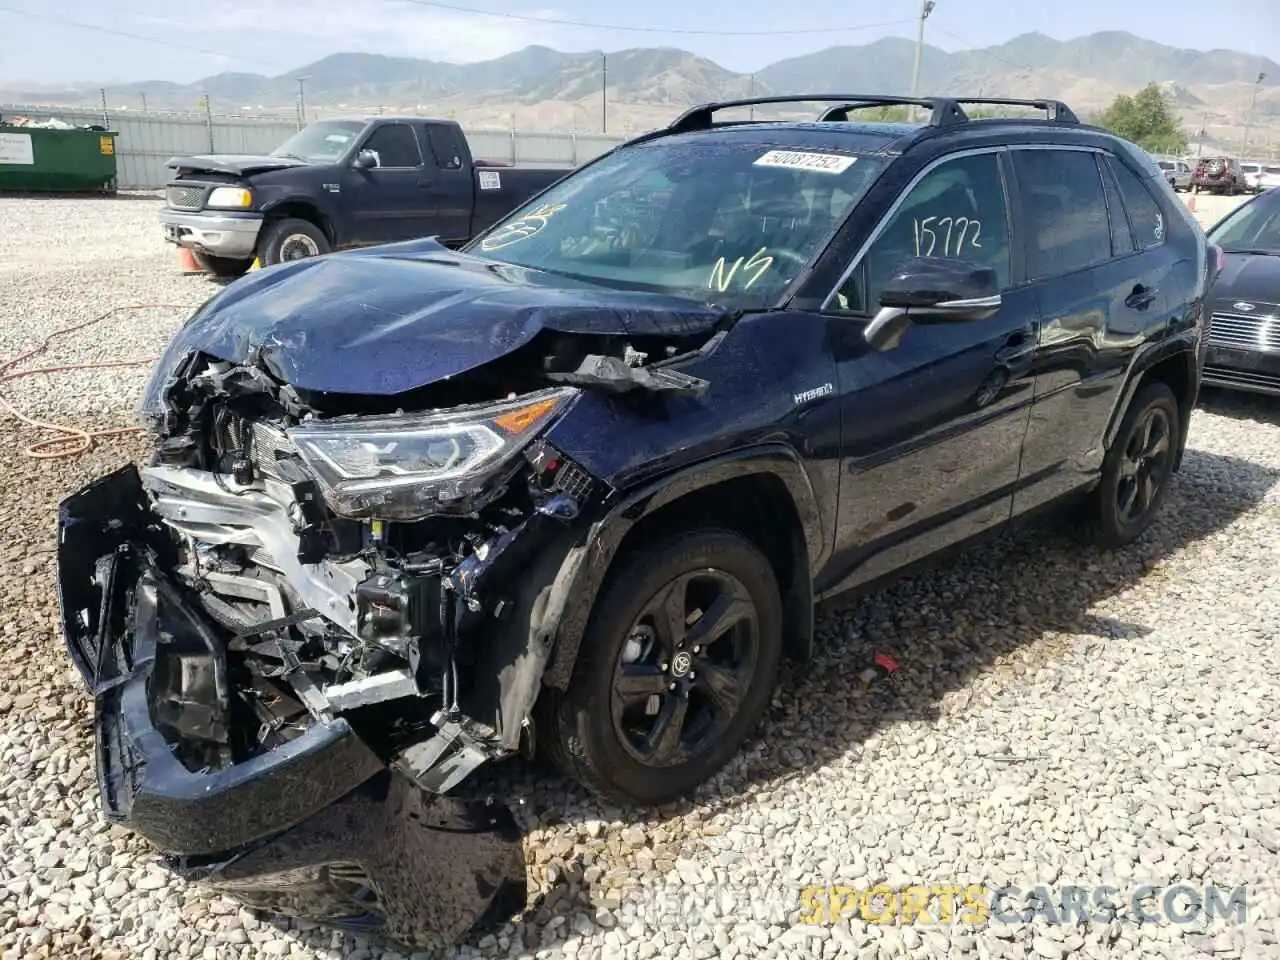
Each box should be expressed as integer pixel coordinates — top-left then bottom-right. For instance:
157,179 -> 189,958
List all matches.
544,529 -> 782,806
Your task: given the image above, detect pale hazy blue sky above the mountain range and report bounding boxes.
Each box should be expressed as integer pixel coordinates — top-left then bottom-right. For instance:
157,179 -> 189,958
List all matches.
0,0 -> 1280,83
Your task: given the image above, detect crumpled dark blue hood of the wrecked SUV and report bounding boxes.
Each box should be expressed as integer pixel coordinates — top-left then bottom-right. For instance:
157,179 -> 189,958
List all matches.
145,241 -> 727,406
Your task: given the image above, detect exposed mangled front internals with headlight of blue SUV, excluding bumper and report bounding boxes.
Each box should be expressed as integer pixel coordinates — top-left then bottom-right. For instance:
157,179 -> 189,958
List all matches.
140,356 -> 634,792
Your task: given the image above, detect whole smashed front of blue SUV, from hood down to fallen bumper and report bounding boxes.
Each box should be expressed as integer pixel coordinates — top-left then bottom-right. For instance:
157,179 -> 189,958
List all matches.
58,243 -> 736,946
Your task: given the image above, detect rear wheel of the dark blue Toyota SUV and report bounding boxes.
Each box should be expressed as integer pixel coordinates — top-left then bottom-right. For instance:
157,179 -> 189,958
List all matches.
1085,381 -> 1181,549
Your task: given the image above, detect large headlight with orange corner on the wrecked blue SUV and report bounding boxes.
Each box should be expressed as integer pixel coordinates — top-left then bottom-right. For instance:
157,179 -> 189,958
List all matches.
288,388 -> 579,521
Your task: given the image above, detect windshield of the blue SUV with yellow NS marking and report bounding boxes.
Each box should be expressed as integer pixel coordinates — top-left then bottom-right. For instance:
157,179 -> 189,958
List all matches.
465,134 -> 883,307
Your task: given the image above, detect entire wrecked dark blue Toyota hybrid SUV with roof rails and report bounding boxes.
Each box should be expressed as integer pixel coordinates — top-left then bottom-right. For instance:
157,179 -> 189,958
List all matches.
59,95 -> 1213,945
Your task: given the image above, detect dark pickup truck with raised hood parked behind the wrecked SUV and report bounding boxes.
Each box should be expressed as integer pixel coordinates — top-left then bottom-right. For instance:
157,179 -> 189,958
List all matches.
160,116 -> 568,276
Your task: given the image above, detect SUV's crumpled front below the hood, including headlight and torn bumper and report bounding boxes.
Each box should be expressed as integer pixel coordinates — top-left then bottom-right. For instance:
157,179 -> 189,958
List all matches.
59,355 -> 616,947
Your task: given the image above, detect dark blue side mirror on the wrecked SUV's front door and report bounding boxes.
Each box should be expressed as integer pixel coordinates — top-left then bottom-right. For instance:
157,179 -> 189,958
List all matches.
863,257 -> 1001,351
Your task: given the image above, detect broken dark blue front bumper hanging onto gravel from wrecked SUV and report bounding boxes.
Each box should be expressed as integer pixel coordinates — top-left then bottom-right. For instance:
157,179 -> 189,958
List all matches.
58,466 -> 526,948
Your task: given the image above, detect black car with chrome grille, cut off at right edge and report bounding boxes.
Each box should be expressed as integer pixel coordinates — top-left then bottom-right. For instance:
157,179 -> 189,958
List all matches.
1204,189 -> 1280,396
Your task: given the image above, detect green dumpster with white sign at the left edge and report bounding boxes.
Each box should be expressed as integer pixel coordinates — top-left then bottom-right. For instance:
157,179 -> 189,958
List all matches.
0,124 -> 118,193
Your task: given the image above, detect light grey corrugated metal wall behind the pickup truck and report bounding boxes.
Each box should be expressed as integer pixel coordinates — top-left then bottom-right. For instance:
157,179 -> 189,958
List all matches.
0,104 -> 623,189
